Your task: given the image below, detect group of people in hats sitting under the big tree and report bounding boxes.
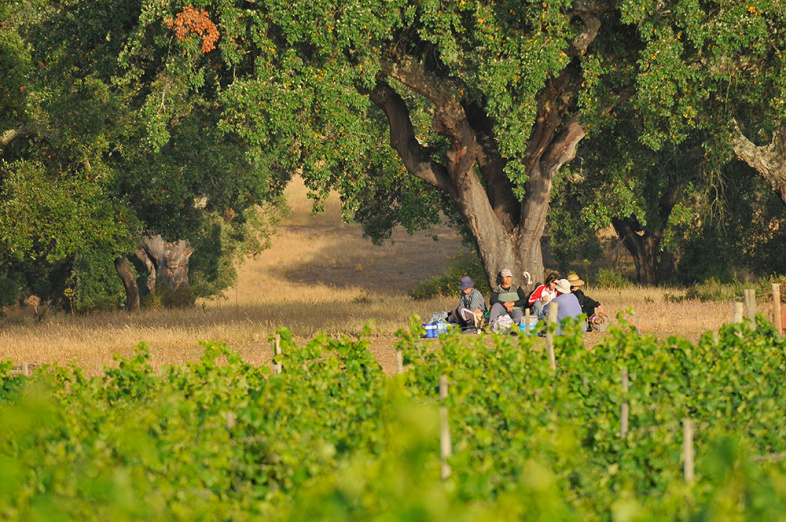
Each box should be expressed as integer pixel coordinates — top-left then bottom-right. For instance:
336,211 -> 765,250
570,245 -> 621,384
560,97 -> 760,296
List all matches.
451,268 -> 605,333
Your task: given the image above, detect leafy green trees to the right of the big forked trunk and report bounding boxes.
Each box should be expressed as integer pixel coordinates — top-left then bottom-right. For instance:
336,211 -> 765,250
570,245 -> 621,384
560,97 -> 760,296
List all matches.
551,1 -> 786,283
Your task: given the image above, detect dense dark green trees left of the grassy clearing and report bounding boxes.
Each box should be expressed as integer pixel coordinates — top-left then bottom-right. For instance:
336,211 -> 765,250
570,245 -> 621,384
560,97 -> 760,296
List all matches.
0,1 -> 283,311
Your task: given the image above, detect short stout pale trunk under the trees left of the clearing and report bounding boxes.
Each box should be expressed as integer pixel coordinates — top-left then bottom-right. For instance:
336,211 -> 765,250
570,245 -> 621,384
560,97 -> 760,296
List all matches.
136,235 -> 194,293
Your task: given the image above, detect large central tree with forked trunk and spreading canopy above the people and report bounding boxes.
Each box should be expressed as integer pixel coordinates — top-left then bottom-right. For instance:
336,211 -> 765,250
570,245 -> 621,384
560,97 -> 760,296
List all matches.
128,0 -> 624,286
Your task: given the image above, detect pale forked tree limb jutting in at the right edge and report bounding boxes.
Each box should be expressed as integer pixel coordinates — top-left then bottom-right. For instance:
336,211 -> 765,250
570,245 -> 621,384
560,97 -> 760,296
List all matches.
732,119 -> 786,205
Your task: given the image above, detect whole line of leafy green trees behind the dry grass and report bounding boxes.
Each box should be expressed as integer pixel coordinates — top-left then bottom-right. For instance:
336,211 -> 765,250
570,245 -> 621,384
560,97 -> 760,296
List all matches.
0,0 -> 786,309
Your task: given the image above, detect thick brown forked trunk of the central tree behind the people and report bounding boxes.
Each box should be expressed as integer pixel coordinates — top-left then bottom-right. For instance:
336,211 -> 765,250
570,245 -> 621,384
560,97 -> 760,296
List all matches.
369,65 -> 584,286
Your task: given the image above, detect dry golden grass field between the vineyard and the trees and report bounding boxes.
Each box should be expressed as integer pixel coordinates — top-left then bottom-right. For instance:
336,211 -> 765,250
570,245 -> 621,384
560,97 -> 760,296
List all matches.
0,177 -> 767,373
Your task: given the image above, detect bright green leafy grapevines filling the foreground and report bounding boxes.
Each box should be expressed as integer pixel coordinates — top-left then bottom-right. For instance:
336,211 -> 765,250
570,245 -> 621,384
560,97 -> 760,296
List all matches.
0,316 -> 786,521
